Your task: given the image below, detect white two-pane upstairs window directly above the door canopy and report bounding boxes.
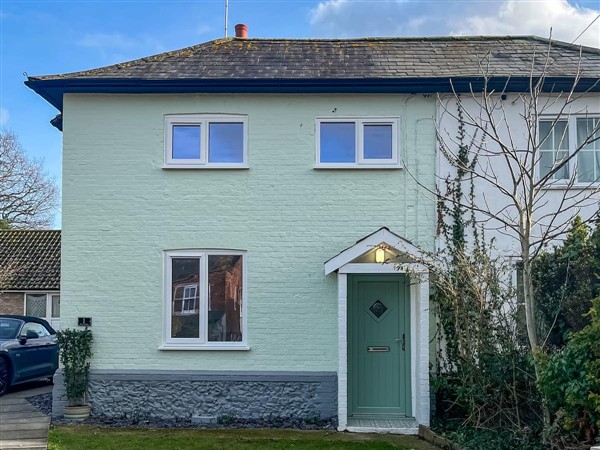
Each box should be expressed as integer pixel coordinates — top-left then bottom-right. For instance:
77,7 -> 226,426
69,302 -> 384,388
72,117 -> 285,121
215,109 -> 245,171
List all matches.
315,117 -> 401,169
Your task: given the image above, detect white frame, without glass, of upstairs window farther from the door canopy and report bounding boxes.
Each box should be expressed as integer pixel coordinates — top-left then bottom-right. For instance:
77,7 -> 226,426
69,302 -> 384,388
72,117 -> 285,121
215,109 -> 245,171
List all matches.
163,114 -> 248,169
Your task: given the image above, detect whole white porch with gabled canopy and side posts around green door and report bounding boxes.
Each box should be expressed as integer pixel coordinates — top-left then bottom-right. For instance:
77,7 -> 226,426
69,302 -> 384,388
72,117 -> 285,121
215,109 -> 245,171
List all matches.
325,227 -> 430,434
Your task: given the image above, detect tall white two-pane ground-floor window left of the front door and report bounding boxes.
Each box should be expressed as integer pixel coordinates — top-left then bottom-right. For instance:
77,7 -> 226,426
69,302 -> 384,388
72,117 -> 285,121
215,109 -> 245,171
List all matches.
160,250 -> 249,350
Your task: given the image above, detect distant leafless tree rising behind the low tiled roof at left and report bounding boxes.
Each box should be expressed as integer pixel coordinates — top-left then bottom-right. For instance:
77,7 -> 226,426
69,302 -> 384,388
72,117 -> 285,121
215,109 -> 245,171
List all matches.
0,130 -> 59,228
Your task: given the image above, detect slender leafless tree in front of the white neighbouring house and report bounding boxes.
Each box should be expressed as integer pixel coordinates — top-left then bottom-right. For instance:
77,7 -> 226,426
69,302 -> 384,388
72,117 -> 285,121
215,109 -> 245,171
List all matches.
426,35 -> 600,372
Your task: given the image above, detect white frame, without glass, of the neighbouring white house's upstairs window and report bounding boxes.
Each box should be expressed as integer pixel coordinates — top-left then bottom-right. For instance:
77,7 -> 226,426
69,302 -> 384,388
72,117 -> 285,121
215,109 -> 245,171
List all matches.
537,114 -> 600,189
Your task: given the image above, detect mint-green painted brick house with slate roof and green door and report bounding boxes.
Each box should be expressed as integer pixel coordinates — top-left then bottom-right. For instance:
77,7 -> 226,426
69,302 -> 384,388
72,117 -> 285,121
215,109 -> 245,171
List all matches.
26,30 -> 599,433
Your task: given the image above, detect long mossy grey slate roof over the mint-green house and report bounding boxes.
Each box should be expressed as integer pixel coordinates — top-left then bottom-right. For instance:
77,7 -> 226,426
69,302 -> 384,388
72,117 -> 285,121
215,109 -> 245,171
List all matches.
30,36 -> 600,80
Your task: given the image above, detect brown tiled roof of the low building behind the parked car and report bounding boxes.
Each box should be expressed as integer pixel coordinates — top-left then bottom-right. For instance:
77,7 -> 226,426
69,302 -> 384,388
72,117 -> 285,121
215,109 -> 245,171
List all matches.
0,230 -> 60,290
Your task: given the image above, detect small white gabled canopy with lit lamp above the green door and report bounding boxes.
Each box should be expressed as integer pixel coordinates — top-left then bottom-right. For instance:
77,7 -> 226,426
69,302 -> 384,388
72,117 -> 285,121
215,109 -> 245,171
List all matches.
325,227 -> 426,275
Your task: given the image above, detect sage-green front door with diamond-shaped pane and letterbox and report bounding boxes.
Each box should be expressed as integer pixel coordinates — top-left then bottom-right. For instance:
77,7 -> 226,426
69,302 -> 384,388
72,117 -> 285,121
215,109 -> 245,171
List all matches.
348,274 -> 411,416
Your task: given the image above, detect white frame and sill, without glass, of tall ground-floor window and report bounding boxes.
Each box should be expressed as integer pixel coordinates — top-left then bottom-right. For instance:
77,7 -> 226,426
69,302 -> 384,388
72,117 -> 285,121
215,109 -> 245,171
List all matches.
159,249 -> 250,350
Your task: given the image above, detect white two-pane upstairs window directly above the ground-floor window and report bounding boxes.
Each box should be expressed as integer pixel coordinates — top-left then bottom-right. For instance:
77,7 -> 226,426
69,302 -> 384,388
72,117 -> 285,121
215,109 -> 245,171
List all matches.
164,114 -> 248,169
